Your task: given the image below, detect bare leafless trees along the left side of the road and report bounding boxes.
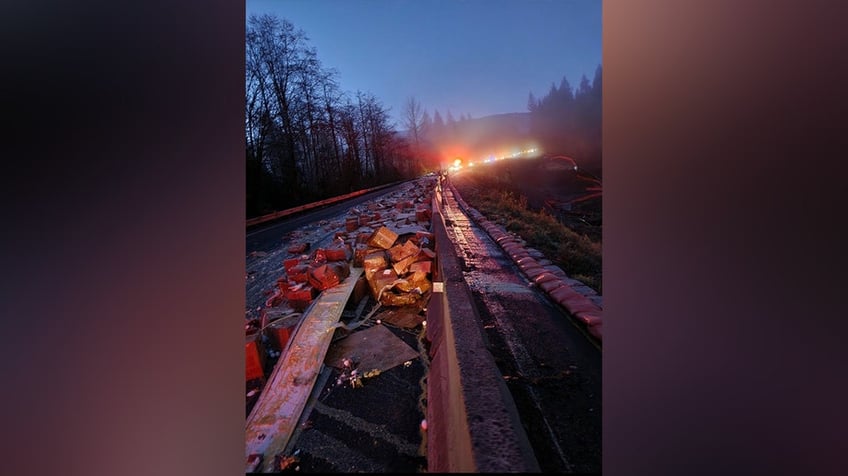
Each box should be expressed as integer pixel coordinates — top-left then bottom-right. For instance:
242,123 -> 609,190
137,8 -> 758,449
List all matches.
245,14 -> 420,217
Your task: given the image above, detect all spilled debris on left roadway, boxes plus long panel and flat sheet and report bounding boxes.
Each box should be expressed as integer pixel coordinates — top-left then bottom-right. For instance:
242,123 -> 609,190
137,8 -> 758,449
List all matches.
246,181 -> 436,471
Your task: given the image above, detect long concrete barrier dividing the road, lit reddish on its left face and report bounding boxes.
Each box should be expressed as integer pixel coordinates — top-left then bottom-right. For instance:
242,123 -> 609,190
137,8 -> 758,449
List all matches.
427,178 -> 540,473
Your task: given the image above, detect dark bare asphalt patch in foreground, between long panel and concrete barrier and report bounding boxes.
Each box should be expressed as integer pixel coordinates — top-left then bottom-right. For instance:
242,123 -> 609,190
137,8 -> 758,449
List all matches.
288,308 -> 427,473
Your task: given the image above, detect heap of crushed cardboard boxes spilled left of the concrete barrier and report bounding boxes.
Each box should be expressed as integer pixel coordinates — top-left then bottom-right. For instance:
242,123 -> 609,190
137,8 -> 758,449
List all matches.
247,180 -> 436,390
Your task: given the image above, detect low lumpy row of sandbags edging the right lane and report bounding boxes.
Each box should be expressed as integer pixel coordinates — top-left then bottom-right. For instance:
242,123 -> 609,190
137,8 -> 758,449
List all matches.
448,179 -> 603,342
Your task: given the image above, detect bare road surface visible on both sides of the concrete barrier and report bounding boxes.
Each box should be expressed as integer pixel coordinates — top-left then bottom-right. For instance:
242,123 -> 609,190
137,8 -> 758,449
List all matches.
246,178 -> 602,474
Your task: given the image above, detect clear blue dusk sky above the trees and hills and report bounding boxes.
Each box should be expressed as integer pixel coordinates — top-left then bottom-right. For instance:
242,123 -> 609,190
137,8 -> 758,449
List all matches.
245,0 -> 602,129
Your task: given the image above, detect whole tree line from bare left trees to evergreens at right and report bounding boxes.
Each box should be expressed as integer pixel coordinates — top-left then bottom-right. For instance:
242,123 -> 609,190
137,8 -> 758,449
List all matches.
244,14 -> 601,218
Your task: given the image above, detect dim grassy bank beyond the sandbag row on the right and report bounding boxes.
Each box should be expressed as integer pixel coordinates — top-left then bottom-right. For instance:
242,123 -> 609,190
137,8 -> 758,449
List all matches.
452,167 -> 603,294
